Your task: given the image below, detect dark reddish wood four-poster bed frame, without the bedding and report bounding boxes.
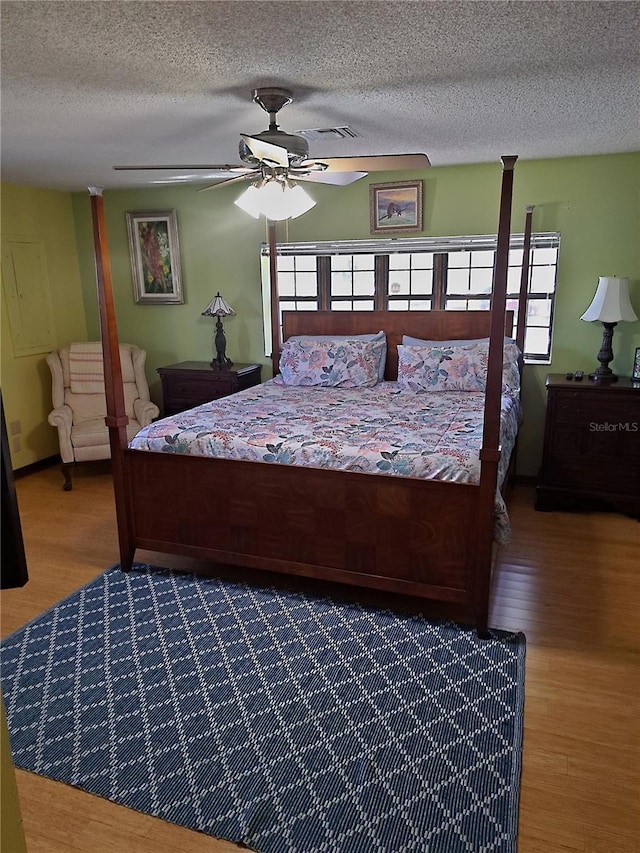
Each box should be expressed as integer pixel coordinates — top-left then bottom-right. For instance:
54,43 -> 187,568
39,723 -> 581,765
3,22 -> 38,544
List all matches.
91,157 -> 531,635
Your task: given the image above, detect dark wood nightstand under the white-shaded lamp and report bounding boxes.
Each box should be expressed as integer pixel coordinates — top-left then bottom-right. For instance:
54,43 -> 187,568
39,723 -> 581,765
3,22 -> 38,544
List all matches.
535,374 -> 640,518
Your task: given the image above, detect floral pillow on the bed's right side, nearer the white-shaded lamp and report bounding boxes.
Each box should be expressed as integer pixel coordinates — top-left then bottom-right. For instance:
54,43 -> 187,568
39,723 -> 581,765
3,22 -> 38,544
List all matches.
398,344 -> 486,391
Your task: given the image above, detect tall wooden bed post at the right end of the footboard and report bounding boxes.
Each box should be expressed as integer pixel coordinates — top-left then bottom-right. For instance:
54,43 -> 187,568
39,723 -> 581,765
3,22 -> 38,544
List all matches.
472,156 -> 518,637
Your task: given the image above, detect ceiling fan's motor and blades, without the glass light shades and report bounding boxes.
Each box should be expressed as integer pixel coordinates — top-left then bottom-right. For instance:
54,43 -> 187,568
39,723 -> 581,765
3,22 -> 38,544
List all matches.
113,86 -> 430,189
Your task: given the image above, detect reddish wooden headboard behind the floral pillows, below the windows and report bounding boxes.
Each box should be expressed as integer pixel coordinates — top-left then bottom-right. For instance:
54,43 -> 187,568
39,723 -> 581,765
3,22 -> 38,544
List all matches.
282,311 -> 513,380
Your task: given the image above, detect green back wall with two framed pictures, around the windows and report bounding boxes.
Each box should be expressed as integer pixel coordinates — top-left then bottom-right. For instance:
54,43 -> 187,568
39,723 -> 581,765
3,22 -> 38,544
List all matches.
73,152 -> 640,475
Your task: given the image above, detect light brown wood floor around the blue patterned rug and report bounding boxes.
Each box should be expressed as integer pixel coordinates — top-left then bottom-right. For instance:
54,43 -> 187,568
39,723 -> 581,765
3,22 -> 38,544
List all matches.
0,463 -> 640,853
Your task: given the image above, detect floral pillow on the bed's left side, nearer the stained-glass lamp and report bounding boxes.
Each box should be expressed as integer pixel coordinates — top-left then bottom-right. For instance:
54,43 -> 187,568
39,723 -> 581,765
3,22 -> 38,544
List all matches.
275,339 -> 386,388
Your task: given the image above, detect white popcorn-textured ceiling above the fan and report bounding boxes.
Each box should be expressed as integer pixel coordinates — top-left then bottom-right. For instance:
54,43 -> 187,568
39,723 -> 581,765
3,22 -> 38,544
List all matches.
0,0 -> 640,190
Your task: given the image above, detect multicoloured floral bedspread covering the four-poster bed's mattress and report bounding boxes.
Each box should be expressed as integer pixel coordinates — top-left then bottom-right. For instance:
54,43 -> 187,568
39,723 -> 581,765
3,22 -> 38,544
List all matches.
130,380 -> 519,542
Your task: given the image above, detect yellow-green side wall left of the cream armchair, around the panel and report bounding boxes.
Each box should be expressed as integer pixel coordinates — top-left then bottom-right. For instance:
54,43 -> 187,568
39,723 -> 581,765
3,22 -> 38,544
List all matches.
0,184 -> 87,469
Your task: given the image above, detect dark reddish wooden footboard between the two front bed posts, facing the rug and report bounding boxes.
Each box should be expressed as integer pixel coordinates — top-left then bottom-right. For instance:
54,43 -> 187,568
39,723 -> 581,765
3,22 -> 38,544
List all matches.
125,450 -> 489,625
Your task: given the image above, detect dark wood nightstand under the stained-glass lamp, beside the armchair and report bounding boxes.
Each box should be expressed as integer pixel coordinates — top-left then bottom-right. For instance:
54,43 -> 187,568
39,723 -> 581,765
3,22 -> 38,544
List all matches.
158,361 -> 262,417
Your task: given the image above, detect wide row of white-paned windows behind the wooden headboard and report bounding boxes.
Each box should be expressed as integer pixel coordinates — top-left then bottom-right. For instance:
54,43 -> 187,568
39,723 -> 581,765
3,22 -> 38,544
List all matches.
262,232 -> 560,362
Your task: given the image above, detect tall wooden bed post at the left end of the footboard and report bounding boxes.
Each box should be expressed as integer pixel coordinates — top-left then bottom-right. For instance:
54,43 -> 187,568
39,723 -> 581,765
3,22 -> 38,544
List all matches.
89,187 -> 135,572
